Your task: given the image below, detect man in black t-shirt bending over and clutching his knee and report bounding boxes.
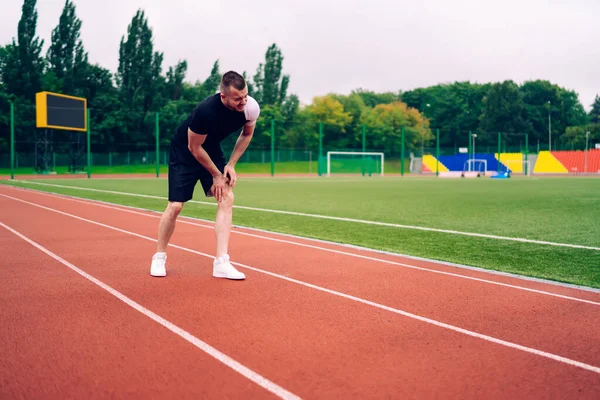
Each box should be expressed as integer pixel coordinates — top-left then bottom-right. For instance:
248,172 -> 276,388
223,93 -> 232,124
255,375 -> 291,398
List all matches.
150,71 -> 260,279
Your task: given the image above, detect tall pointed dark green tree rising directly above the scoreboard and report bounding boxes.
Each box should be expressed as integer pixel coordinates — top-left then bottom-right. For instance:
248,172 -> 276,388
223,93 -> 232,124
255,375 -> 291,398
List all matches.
47,0 -> 88,96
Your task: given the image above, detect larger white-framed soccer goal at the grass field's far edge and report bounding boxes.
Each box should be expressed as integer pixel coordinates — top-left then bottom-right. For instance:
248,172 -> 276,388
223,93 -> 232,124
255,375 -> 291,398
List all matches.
327,151 -> 385,176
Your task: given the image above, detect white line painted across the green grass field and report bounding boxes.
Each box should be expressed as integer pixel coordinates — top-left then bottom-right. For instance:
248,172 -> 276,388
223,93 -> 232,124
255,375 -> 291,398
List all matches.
9,181 -> 600,251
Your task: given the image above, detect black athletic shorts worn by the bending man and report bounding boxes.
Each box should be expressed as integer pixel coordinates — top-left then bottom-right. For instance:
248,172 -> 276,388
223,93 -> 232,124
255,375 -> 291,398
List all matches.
169,144 -> 227,203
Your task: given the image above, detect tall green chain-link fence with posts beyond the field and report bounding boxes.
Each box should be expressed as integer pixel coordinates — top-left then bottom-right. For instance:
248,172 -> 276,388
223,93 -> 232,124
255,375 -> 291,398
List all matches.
0,100 -> 588,176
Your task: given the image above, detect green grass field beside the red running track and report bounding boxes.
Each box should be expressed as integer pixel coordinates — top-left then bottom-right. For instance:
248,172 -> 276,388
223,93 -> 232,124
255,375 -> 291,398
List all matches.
1,171 -> 600,288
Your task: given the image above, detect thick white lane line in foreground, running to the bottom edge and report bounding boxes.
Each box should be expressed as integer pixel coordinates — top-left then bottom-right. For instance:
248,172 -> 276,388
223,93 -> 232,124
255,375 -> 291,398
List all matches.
0,222 -> 300,399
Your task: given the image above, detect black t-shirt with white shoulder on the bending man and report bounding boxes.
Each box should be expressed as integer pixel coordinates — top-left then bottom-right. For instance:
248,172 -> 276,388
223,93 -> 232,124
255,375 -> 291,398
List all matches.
172,93 -> 260,163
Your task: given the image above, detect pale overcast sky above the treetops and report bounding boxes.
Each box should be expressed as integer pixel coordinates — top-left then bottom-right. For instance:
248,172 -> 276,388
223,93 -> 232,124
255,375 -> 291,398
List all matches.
0,0 -> 600,110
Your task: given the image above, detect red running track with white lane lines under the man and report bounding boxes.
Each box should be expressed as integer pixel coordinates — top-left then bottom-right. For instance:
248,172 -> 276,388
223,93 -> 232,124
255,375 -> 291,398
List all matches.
0,187 -> 600,399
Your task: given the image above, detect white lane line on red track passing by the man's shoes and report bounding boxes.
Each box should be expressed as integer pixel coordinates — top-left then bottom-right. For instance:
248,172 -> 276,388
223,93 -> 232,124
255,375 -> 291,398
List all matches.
3,195 -> 600,374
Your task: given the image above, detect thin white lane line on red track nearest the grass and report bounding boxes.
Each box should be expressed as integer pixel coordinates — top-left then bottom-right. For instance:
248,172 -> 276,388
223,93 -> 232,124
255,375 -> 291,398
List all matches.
3,192 -> 600,306
